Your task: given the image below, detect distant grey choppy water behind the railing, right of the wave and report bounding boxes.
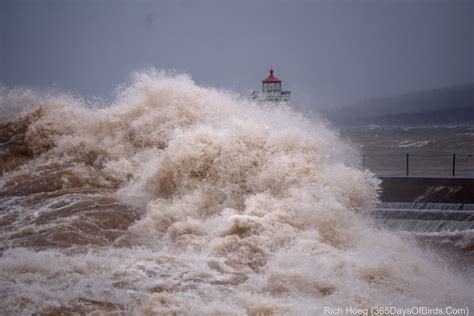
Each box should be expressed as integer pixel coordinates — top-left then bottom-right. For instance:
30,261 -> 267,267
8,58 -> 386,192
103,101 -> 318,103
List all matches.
342,126 -> 474,177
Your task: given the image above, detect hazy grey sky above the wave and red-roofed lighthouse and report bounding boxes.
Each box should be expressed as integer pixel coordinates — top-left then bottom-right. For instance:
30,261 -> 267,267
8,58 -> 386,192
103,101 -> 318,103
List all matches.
0,0 -> 474,107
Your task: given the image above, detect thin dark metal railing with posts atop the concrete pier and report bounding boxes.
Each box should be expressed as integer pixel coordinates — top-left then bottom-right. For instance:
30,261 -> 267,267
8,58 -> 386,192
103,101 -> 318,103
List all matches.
362,153 -> 474,177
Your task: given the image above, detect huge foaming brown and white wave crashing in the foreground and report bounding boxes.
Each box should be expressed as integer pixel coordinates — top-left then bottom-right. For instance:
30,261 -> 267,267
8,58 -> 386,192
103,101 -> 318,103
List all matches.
0,73 -> 473,315
